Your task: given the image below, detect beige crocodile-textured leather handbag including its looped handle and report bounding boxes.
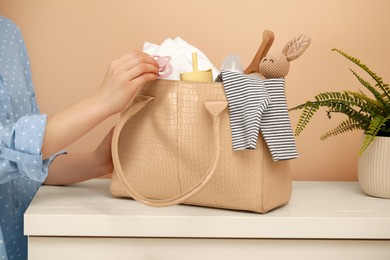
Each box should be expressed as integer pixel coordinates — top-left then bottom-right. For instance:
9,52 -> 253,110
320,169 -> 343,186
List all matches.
110,80 -> 291,213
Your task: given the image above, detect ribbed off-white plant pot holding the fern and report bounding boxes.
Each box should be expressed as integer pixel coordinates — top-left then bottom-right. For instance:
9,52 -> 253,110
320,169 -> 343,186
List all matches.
358,136 -> 390,199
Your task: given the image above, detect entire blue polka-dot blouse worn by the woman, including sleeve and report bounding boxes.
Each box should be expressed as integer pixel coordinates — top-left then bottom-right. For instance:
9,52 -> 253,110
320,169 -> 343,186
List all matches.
0,16 -> 62,260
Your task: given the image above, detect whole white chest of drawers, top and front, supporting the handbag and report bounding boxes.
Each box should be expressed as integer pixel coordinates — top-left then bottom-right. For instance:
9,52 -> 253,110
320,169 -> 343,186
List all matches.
25,179 -> 390,260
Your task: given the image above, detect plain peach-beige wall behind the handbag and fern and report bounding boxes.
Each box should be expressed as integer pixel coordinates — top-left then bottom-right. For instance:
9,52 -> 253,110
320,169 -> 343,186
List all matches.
0,0 -> 390,180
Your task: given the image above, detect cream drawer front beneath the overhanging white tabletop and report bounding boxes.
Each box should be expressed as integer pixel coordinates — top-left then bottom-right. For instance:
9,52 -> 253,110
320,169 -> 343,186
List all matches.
29,237 -> 390,260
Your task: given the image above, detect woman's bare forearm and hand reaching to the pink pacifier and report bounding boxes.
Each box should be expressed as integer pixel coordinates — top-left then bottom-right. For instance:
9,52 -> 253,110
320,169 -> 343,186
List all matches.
42,51 -> 158,158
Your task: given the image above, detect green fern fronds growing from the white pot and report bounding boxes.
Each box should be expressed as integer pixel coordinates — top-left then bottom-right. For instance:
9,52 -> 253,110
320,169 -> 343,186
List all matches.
290,49 -> 390,155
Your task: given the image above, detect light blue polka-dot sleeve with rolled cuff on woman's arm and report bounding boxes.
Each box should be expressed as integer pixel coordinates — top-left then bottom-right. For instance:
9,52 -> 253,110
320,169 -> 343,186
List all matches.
0,16 -> 64,184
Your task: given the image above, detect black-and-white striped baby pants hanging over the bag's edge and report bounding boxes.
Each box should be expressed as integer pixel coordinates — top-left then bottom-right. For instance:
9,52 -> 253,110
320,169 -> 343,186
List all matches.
216,70 -> 298,161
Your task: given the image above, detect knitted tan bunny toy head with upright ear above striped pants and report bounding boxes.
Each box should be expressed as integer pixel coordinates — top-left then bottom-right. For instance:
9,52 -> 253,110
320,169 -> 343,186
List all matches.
259,34 -> 311,79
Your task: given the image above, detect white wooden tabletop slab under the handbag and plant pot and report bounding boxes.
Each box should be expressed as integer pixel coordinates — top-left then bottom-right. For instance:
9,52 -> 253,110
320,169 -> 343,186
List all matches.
25,179 -> 390,239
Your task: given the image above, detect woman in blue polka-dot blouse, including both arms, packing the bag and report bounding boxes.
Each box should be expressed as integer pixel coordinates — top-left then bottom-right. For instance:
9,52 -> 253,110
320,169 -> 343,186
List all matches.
0,16 -> 158,260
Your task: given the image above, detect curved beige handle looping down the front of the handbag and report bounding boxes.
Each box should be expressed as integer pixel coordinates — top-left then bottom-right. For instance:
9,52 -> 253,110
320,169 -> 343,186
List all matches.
112,95 -> 228,207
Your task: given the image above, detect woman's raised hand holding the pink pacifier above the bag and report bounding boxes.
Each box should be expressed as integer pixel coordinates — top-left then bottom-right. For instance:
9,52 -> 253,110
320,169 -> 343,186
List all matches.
95,51 -> 158,115
